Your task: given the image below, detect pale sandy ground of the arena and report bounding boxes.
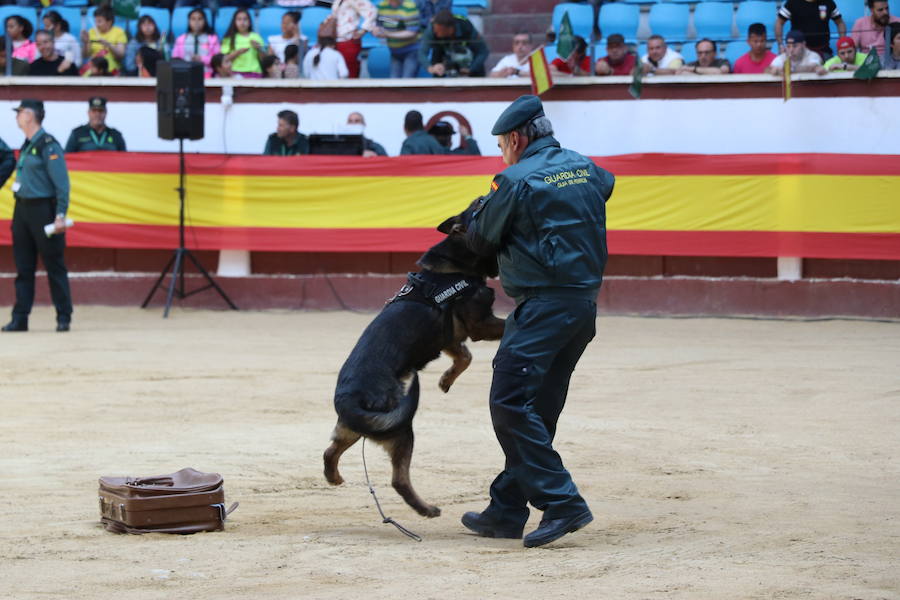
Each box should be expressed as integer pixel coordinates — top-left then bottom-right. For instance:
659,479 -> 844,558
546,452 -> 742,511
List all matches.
0,308 -> 900,600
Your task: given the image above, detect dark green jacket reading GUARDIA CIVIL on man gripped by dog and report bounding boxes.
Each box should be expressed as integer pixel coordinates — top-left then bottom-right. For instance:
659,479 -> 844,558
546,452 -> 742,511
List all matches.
468,136 -> 615,303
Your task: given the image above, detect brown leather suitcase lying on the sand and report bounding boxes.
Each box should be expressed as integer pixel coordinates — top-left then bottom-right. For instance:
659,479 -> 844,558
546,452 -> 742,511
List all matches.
99,468 -> 238,533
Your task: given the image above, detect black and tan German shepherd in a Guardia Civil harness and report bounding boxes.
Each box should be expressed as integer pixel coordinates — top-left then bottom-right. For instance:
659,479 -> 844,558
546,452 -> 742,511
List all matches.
324,200 -> 504,517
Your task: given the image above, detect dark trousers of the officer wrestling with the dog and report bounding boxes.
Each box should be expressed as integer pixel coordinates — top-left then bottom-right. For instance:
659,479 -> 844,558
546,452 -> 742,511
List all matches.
485,289 -> 597,528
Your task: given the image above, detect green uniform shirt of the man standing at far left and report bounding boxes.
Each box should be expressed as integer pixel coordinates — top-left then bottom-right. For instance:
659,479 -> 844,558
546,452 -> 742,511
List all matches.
16,128 -> 69,215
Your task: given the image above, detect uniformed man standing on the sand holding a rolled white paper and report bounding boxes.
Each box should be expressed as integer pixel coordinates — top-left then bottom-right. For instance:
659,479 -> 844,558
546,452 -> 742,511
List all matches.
3,100 -> 72,331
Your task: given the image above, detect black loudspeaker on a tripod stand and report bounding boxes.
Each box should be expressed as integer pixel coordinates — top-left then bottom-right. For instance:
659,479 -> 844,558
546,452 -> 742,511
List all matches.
141,60 -> 237,318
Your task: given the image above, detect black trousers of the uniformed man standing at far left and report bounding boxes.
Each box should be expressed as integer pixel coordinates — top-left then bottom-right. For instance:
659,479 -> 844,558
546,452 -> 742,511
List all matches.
12,198 -> 72,323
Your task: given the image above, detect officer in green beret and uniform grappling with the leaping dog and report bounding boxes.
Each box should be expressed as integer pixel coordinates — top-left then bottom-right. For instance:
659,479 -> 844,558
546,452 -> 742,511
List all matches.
462,96 -> 615,547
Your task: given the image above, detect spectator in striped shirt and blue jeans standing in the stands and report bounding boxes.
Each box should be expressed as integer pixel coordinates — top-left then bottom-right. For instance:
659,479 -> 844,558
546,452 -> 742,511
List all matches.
374,0 -> 420,79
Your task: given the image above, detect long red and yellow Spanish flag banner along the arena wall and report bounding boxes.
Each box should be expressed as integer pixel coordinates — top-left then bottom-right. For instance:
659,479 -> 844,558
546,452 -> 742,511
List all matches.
0,152 -> 900,260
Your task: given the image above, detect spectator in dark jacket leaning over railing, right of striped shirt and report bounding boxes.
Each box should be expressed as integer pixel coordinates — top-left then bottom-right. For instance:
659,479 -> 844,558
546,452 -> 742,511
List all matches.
419,10 -> 489,77
